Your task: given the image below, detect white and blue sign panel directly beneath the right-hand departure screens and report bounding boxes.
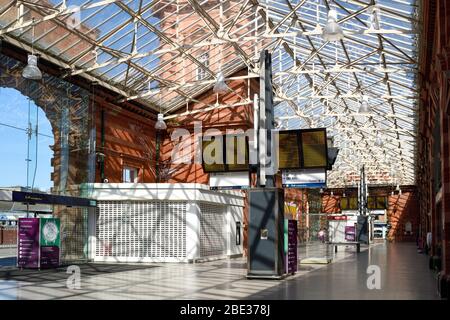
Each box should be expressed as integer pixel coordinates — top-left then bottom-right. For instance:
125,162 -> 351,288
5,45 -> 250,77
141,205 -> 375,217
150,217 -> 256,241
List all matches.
282,169 -> 327,188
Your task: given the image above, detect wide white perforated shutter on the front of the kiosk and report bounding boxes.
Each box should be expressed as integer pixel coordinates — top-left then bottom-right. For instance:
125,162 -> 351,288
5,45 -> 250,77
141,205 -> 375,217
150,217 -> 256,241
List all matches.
96,201 -> 186,258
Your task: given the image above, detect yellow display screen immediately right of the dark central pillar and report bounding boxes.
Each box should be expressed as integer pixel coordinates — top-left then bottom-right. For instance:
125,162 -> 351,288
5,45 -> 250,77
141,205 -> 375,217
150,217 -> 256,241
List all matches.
278,130 -> 301,169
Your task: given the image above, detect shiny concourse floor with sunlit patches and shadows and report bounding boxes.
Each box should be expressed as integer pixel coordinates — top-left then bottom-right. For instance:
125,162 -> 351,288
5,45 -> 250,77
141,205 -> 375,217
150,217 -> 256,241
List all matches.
0,243 -> 440,300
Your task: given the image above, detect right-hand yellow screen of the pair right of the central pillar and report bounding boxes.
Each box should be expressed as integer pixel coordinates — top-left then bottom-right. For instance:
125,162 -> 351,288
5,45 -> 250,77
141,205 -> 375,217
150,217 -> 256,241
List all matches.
300,129 -> 328,169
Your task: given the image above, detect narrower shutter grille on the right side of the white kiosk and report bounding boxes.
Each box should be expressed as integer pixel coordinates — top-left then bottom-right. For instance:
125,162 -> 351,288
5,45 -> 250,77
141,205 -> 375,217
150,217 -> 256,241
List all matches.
200,203 -> 227,257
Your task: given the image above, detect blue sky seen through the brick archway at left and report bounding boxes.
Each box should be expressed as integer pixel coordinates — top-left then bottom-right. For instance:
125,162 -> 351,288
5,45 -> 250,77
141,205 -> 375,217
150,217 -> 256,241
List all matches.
0,88 -> 54,191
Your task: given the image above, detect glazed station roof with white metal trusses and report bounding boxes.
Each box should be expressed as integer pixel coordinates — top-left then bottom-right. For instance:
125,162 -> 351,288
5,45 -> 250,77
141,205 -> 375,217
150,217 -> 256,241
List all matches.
0,0 -> 420,187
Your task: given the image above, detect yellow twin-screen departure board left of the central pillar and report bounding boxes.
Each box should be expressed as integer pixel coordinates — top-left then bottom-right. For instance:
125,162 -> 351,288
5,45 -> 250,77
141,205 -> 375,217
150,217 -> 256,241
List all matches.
202,135 -> 249,172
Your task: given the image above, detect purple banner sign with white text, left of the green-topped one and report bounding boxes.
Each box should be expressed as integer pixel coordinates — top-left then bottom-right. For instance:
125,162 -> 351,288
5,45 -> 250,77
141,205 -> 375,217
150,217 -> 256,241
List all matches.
17,218 -> 39,268
